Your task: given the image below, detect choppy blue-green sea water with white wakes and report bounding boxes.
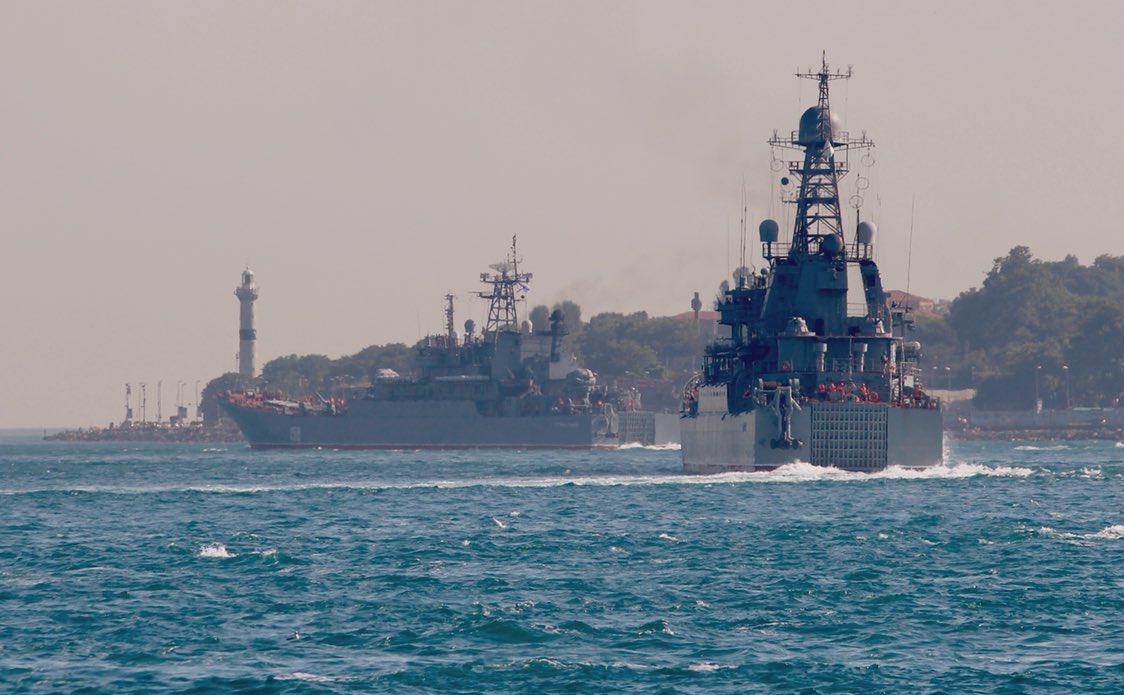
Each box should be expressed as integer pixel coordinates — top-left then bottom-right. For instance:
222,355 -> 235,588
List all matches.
0,435 -> 1124,693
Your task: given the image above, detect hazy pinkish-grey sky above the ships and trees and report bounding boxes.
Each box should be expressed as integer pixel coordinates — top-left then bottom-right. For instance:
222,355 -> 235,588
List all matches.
0,0 -> 1124,426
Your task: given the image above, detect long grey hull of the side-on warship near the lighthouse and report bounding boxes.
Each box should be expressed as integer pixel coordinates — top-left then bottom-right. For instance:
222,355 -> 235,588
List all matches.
224,400 -> 674,449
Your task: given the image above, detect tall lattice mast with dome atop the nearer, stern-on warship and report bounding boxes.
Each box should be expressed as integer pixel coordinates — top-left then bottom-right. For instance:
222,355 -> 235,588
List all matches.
769,53 -> 874,256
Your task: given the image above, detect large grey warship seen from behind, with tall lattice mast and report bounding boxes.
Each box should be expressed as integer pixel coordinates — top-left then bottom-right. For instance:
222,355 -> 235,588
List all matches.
680,58 -> 943,473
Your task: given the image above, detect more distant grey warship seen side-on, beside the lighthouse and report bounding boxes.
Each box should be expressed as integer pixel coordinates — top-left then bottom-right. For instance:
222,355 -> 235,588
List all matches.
223,238 -> 679,449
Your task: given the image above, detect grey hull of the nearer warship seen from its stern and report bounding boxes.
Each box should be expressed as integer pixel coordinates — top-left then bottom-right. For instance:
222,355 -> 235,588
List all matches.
680,401 -> 944,473
